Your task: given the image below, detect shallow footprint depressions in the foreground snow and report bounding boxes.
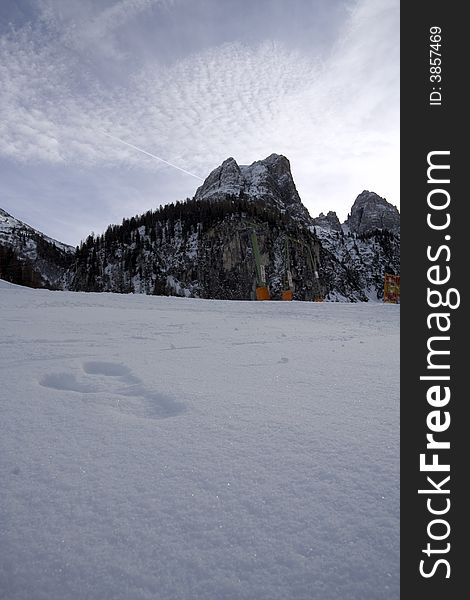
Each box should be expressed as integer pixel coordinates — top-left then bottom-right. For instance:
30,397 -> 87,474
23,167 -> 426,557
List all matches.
39,360 -> 186,419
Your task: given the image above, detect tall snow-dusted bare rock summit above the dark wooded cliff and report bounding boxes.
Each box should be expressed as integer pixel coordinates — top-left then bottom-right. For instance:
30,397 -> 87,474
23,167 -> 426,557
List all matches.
195,154 -> 310,222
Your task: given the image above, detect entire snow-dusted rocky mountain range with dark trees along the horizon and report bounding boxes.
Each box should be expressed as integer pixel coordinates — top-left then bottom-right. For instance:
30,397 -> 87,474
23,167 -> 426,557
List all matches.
0,154 -> 400,302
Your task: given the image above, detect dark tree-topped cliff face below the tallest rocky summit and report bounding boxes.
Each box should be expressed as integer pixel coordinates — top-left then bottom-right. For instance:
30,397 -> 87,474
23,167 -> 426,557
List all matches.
72,196 -> 322,300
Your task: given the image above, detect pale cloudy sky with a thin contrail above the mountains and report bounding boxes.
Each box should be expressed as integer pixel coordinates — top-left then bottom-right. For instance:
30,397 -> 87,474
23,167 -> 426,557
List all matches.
0,0 -> 399,244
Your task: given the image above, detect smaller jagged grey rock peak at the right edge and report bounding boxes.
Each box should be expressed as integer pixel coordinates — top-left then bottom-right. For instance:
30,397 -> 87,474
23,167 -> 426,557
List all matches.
345,190 -> 400,235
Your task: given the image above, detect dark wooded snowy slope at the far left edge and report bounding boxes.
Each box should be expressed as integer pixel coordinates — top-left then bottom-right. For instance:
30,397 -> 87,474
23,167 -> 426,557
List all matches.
0,208 -> 75,289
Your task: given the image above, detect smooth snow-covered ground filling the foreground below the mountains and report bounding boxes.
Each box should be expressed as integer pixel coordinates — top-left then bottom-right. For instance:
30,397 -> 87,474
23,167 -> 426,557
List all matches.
0,282 -> 399,600
